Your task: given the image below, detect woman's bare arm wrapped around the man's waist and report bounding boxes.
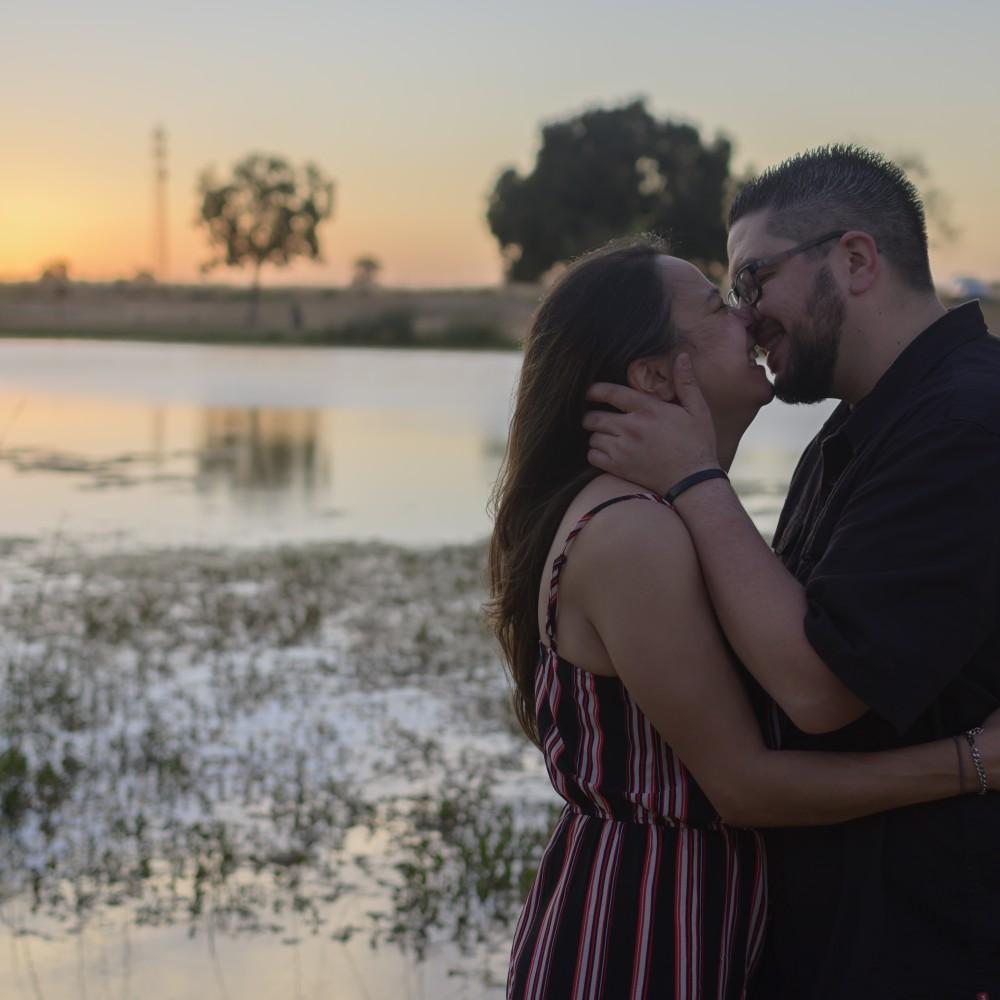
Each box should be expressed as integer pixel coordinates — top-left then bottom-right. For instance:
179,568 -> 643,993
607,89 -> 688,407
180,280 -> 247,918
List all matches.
576,504 -> 1000,826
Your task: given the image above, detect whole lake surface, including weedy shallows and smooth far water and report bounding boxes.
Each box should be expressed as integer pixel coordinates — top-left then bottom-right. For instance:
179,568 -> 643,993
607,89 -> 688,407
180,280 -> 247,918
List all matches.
0,340 -> 831,1000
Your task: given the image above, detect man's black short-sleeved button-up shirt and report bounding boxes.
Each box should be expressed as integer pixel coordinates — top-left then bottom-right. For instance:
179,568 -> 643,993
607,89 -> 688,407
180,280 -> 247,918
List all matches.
755,303 -> 1000,1000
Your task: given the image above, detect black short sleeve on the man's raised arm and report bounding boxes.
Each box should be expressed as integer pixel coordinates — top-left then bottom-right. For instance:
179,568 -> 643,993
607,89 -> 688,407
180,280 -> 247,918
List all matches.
805,420 -> 1000,734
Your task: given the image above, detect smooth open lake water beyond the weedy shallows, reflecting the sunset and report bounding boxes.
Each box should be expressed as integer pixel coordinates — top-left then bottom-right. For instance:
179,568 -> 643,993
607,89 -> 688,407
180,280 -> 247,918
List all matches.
0,340 -> 831,549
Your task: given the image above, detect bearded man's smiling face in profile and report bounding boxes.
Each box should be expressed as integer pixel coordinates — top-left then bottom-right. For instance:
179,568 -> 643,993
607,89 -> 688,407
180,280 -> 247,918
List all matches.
729,212 -> 845,403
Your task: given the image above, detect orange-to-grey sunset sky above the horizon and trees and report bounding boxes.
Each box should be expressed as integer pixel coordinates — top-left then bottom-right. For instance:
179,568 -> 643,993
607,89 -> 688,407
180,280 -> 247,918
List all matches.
0,0 -> 1000,286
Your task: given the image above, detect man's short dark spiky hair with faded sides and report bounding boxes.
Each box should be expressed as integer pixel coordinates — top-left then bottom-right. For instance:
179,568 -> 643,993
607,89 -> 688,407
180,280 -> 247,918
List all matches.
729,145 -> 934,291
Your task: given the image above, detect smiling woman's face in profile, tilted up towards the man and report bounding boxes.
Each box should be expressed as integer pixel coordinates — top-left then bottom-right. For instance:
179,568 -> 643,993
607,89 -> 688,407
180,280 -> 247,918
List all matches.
659,257 -> 774,424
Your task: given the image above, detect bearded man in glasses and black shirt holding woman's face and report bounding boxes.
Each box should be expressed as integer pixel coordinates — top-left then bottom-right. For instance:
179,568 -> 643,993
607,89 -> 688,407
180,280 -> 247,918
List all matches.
585,146 -> 1000,1000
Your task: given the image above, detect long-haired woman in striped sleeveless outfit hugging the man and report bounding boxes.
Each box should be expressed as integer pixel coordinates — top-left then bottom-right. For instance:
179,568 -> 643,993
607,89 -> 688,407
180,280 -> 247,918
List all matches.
490,238 -> 1000,1000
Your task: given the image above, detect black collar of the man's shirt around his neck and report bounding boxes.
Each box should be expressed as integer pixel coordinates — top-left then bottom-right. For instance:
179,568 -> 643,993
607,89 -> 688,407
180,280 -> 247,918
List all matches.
829,302 -> 989,448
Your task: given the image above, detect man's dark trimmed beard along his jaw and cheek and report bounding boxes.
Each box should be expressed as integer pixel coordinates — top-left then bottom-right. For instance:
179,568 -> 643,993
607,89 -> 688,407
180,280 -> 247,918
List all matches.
774,265 -> 845,403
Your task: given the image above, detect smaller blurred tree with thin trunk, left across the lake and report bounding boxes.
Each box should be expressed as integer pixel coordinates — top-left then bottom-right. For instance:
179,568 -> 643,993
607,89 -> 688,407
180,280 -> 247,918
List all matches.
198,153 -> 333,317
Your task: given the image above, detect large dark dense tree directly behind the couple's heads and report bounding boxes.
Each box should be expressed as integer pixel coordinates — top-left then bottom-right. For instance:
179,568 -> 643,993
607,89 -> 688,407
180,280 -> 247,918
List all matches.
487,100 -> 732,281
